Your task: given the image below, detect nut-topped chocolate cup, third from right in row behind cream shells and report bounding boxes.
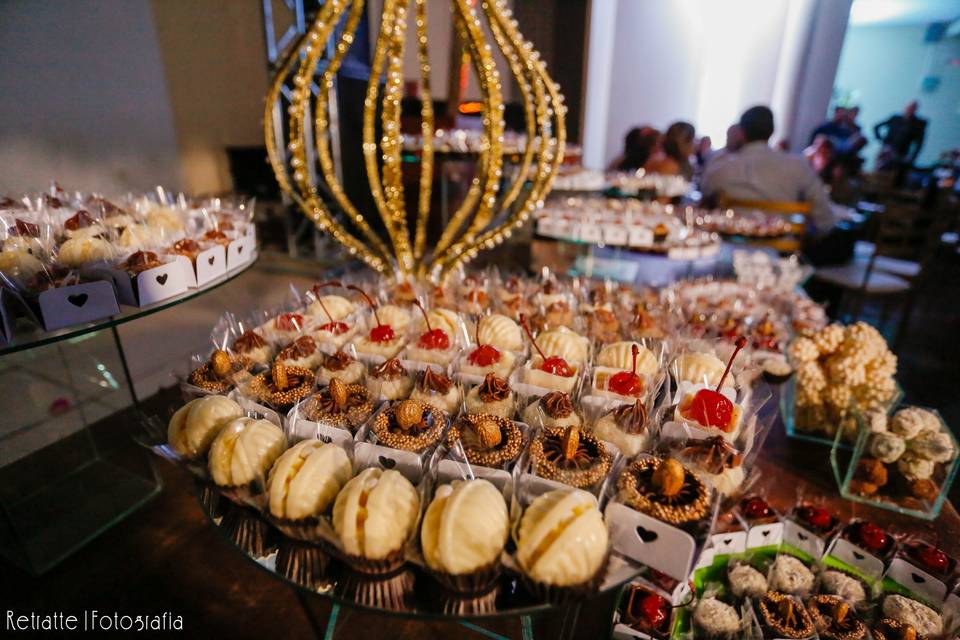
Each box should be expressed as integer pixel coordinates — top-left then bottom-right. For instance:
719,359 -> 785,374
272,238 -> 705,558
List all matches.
447,413 -> 526,467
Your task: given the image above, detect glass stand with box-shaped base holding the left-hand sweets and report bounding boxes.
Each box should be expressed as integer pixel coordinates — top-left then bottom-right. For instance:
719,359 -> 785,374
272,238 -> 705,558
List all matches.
0,261 -> 253,575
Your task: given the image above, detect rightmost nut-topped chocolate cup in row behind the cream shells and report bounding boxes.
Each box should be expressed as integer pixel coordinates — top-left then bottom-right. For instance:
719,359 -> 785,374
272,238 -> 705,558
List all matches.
617,457 -> 710,526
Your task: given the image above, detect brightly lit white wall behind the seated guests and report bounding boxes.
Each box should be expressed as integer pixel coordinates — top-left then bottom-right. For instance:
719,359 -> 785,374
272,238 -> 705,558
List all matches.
584,0 -> 851,168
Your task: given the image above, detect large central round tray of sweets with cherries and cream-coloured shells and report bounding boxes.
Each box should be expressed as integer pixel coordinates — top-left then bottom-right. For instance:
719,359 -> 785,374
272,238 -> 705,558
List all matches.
133,272 -> 824,617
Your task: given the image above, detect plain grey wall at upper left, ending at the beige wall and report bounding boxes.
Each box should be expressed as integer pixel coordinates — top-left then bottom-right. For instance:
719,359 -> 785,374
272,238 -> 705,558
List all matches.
0,0 -> 183,193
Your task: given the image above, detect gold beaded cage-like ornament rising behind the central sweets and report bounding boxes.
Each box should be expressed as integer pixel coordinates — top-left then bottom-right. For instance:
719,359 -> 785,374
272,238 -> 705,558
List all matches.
264,0 -> 566,280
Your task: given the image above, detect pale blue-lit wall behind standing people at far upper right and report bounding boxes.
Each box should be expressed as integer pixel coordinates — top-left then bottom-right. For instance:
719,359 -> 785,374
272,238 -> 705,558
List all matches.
836,25 -> 960,166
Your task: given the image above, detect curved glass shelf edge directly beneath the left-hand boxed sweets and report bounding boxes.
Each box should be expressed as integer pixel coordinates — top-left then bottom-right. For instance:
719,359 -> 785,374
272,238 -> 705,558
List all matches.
0,254 -> 257,356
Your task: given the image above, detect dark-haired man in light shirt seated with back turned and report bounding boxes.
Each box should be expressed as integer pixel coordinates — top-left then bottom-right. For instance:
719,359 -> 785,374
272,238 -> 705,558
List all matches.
701,106 -> 834,235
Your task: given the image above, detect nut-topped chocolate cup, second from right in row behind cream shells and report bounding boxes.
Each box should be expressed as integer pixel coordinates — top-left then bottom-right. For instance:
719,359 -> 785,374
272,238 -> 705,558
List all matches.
530,426 -> 611,488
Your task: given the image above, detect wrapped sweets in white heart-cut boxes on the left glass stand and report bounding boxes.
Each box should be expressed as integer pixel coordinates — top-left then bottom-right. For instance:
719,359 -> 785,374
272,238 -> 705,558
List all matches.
0,183 -> 257,343
